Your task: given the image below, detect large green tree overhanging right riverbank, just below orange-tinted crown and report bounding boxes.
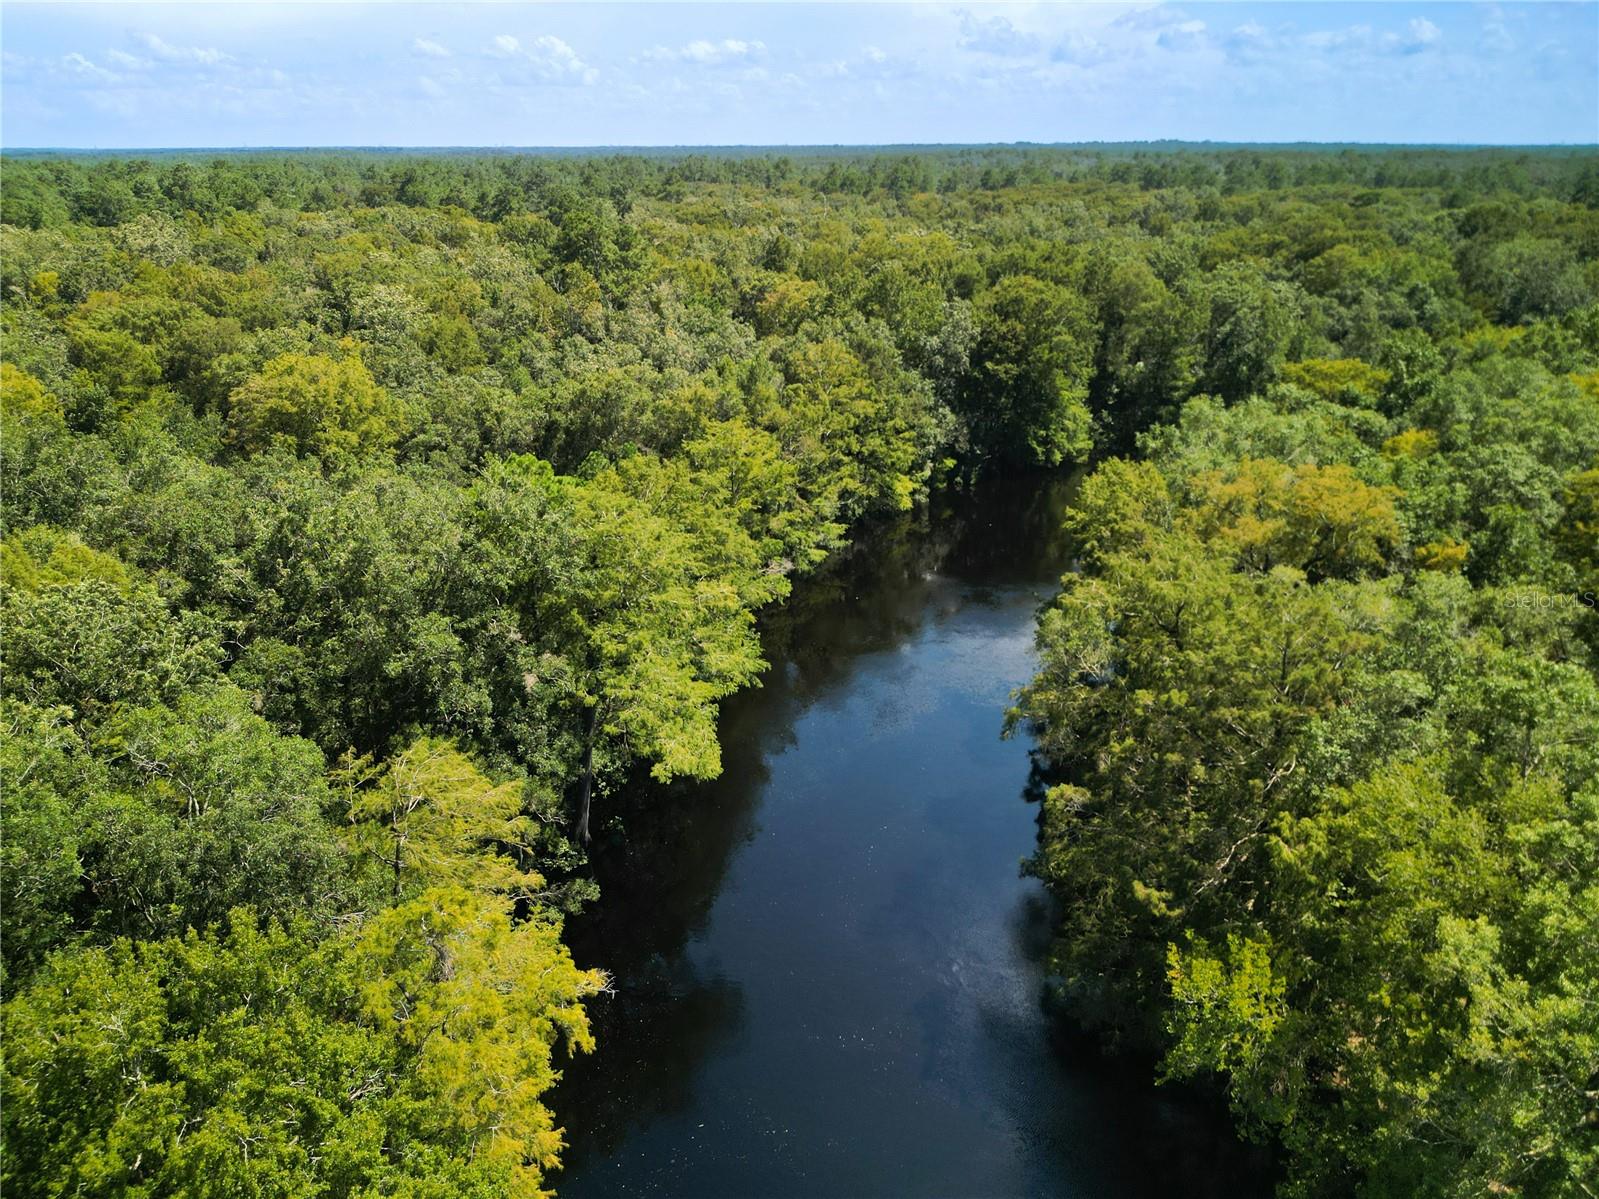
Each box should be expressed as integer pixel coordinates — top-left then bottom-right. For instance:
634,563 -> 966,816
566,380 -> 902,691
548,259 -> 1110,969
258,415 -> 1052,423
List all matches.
1012,529 -> 1372,1020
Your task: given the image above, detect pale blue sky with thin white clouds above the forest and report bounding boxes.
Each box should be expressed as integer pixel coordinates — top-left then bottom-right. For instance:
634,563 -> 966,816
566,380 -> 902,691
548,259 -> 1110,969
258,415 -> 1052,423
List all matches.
0,2 -> 1599,149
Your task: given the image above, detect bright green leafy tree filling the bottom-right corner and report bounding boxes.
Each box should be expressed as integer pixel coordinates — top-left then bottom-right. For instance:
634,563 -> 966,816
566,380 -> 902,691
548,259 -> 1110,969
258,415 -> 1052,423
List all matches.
1167,759 -> 1599,1196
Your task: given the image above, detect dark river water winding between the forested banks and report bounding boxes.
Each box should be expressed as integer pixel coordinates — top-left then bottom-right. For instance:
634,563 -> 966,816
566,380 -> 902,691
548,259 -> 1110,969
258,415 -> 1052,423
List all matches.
552,480 -> 1270,1199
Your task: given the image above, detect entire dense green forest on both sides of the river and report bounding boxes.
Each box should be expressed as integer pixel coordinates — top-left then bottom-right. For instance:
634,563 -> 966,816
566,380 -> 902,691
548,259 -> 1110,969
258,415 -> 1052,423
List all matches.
0,147 -> 1599,1199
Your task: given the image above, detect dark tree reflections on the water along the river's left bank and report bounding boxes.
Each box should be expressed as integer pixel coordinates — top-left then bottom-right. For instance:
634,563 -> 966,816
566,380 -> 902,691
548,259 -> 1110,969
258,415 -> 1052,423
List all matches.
552,478 -> 1070,1170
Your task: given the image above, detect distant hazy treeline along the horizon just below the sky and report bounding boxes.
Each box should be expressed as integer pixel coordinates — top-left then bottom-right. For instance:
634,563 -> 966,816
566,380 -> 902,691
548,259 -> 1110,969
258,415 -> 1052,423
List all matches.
0,142 -> 1599,229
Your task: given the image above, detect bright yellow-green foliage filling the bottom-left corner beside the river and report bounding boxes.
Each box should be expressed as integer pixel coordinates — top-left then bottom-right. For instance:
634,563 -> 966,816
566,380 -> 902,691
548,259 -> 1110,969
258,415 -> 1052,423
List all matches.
3,889 -> 603,1197
